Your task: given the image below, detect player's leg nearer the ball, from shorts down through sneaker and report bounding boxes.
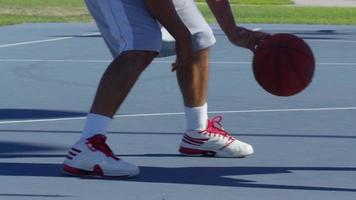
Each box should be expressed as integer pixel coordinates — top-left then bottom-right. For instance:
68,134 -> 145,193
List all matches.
173,0 -> 253,157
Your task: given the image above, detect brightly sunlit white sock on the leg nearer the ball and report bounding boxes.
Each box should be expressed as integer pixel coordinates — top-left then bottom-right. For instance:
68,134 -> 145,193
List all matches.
185,103 -> 208,131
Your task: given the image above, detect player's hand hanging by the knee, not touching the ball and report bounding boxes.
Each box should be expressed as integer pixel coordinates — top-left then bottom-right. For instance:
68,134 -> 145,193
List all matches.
172,41 -> 193,71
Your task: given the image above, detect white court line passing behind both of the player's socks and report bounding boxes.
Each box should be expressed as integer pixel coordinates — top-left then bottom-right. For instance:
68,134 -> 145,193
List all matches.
0,107 -> 356,124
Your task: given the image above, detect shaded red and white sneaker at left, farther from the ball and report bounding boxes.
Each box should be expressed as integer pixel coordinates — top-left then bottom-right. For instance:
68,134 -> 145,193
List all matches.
63,135 -> 140,178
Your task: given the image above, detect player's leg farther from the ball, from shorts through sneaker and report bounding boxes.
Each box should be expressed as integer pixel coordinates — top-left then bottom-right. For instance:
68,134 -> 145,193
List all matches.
63,0 -> 161,178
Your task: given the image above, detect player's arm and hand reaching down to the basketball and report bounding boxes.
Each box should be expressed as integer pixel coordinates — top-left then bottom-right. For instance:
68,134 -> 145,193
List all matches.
206,0 -> 269,51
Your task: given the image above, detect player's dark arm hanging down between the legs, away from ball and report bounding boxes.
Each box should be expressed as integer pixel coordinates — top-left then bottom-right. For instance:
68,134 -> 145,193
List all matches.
145,0 -> 193,69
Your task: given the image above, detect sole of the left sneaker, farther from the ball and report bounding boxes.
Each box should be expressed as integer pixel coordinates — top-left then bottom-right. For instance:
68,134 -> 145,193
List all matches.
63,165 -> 133,179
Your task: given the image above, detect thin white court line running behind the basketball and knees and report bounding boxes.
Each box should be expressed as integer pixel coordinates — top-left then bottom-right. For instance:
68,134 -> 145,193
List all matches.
0,59 -> 356,66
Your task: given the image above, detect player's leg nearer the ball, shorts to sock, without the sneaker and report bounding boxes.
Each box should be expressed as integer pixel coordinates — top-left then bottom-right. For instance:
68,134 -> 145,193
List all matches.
173,0 -> 215,130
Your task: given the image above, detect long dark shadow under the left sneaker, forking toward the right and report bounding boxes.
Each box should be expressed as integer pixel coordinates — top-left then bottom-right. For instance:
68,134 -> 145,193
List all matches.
0,163 -> 356,192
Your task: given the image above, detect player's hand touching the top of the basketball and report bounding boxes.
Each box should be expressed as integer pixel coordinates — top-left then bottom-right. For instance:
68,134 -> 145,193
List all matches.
228,26 -> 270,51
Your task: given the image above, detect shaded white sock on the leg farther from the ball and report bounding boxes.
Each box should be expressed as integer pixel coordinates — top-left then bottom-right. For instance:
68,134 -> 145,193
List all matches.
81,113 -> 112,139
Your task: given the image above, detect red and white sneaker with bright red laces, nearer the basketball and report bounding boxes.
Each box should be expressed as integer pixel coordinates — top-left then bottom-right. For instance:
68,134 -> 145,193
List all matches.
179,116 -> 253,157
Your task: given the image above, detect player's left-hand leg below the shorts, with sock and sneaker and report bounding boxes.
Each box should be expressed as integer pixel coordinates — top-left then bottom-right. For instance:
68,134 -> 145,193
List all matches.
64,51 -> 157,178
